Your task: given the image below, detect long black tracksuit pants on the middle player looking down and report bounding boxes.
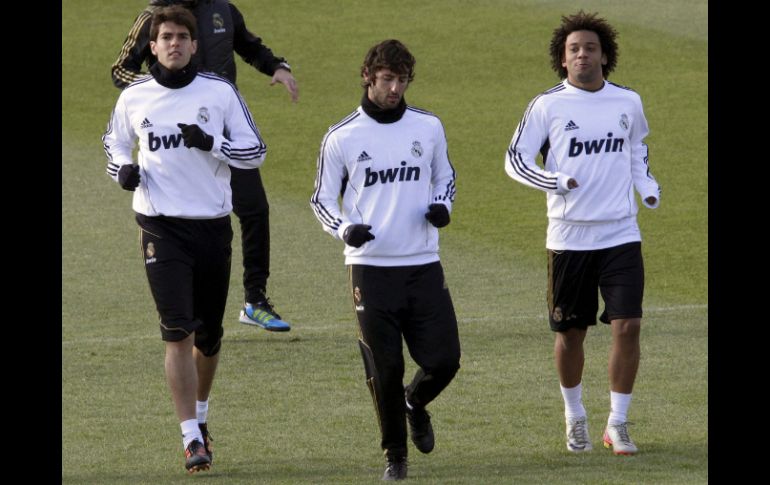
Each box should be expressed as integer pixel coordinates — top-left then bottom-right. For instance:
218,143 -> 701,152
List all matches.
349,262 -> 460,458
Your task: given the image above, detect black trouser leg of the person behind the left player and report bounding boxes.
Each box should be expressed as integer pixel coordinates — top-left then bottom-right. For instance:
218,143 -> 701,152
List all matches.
230,166 -> 270,303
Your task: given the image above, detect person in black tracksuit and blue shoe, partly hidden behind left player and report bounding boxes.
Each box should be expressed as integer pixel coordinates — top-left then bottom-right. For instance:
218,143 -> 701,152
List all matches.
112,0 -> 299,331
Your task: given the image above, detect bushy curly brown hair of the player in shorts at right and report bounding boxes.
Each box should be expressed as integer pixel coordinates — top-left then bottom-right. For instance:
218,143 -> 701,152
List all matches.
550,10 -> 618,79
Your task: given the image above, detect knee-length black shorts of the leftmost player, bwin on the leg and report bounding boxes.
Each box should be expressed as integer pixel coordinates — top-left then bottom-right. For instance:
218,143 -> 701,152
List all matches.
136,214 -> 233,355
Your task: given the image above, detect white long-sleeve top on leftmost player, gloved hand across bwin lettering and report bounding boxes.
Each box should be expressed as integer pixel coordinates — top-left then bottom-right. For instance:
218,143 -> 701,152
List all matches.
102,73 -> 267,219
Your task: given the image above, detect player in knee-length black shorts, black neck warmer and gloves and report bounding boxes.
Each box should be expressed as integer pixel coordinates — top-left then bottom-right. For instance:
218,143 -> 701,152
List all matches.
102,6 -> 266,473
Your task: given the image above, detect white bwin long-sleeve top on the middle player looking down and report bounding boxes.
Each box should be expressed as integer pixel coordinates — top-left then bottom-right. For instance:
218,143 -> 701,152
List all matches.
310,106 -> 456,266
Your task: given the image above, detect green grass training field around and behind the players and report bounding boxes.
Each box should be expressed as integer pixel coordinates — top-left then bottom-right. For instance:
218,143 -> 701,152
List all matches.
62,0 -> 708,484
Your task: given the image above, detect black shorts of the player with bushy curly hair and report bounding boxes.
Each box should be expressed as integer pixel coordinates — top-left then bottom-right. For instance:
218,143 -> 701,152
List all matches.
548,242 -> 644,332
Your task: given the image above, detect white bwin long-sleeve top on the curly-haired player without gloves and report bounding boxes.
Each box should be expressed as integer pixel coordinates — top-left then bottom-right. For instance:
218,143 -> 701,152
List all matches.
505,79 -> 660,250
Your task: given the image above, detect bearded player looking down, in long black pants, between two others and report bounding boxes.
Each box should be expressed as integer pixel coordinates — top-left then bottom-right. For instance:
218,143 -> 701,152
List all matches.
310,40 -> 460,480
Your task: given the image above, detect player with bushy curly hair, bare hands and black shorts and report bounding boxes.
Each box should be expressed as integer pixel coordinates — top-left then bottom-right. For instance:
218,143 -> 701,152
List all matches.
505,10 -> 660,455
